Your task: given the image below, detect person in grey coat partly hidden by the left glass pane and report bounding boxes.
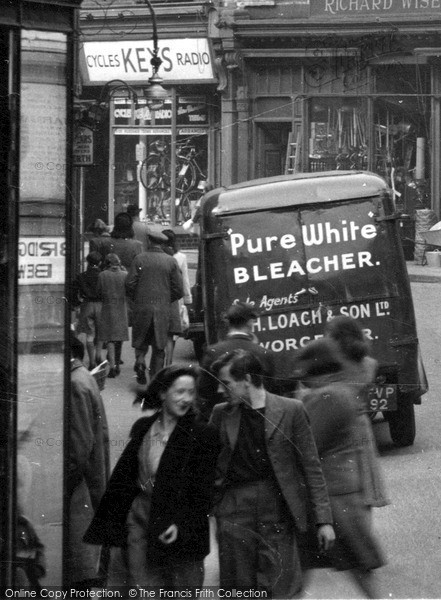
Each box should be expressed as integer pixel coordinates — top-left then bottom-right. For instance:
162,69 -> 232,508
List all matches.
66,338 -> 110,590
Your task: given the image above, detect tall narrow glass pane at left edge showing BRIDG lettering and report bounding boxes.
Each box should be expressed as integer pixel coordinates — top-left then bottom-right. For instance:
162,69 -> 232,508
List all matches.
17,31 -> 67,585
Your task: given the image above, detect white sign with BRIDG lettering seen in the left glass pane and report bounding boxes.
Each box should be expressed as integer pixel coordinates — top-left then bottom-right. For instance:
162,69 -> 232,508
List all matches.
18,236 -> 66,285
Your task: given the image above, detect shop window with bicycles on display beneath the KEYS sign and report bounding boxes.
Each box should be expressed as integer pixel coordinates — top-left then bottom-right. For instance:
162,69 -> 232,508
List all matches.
112,96 -> 208,224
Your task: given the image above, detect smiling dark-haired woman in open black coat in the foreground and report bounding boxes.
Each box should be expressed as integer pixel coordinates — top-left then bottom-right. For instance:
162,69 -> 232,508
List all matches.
84,365 -> 219,588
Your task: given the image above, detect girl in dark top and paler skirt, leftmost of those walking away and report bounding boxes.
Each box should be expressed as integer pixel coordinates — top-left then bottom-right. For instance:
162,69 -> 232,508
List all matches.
72,252 -> 102,371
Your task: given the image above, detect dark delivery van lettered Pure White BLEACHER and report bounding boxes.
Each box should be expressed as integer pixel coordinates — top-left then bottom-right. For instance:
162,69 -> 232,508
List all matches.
191,171 -> 427,446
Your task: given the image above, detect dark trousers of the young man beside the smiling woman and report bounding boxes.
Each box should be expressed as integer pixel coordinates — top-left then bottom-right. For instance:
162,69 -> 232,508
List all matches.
216,480 -> 302,598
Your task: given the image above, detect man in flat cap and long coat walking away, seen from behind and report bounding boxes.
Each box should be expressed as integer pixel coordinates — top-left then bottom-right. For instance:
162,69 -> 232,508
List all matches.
126,225 -> 184,385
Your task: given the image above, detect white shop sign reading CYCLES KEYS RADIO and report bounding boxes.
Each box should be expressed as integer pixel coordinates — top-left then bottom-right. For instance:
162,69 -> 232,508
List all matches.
82,38 -> 215,84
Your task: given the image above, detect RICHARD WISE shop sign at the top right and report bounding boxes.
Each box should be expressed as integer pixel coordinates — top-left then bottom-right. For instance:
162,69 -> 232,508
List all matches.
310,0 -> 441,20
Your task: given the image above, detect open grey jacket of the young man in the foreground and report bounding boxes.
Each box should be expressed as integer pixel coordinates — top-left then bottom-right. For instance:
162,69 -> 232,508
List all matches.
211,392 -> 332,532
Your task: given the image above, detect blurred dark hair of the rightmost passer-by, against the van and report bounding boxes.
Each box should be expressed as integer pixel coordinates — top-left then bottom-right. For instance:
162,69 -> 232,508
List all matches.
325,315 -> 369,362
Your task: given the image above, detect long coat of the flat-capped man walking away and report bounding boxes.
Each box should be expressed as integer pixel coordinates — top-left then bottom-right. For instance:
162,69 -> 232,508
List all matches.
126,246 -> 184,349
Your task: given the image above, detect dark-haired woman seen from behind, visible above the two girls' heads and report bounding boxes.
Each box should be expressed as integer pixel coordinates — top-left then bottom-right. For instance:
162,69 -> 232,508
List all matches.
99,212 -> 143,270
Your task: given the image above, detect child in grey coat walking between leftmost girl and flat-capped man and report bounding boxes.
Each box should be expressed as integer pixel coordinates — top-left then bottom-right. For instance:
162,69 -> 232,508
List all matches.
97,252 -> 129,377
